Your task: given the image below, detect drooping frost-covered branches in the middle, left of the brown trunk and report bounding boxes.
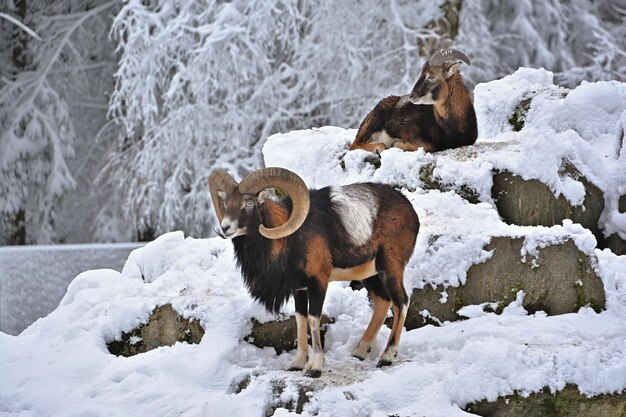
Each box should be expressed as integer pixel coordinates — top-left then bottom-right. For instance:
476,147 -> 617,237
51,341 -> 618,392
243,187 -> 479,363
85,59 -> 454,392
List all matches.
107,0 -> 441,239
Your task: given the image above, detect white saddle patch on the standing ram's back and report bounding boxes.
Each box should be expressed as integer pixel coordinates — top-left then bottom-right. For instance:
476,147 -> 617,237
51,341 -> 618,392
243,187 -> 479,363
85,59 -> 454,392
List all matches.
330,184 -> 378,246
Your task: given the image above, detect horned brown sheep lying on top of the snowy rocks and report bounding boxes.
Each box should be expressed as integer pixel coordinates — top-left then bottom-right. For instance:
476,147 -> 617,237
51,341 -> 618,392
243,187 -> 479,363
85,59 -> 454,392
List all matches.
350,49 -> 478,153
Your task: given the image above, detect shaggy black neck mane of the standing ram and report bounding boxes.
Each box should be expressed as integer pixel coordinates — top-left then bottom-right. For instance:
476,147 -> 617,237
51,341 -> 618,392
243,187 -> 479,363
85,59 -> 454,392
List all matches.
233,201 -> 296,313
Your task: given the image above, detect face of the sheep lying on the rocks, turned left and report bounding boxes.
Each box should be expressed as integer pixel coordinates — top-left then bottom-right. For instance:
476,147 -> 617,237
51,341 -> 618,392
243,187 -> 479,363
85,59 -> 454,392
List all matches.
409,62 -> 461,104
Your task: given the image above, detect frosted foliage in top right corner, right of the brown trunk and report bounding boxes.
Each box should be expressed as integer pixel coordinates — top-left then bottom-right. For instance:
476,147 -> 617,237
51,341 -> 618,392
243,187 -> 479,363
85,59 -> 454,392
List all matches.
458,0 -> 626,87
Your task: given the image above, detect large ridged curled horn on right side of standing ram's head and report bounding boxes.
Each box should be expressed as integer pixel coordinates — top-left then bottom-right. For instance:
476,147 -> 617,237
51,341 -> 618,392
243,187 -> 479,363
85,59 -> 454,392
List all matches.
239,168 -> 311,239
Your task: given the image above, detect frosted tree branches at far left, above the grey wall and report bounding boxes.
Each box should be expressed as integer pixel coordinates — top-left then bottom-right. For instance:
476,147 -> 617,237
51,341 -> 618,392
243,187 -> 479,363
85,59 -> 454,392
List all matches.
0,0 -> 117,244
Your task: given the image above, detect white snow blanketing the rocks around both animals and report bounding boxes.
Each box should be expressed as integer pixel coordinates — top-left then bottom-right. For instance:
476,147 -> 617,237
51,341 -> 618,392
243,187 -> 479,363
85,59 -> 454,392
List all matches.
0,69 -> 626,417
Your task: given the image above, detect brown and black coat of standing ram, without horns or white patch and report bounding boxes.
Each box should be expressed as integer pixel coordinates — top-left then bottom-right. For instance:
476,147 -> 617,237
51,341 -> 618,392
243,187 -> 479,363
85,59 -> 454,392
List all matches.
225,183 -> 419,376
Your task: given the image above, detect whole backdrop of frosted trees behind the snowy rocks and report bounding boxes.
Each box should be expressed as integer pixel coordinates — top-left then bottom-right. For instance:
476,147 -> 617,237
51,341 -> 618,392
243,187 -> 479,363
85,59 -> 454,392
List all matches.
0,0 -> 626,244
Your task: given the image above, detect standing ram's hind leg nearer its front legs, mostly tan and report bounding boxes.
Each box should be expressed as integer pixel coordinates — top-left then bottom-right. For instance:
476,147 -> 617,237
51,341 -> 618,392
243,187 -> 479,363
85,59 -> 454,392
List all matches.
352,275 -> 391,360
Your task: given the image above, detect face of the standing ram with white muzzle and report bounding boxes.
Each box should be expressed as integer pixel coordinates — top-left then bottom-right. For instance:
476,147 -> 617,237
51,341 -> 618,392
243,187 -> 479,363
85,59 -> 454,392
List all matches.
219,191 -> 257,239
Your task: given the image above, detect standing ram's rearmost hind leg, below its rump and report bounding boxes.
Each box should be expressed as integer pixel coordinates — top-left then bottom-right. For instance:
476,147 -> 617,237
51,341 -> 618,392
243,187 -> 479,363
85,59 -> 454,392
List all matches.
376,262 -> 409,367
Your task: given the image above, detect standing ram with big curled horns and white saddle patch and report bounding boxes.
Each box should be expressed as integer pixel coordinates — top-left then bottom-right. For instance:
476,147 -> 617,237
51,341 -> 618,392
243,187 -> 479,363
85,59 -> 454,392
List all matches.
209,168 -> 419,377
